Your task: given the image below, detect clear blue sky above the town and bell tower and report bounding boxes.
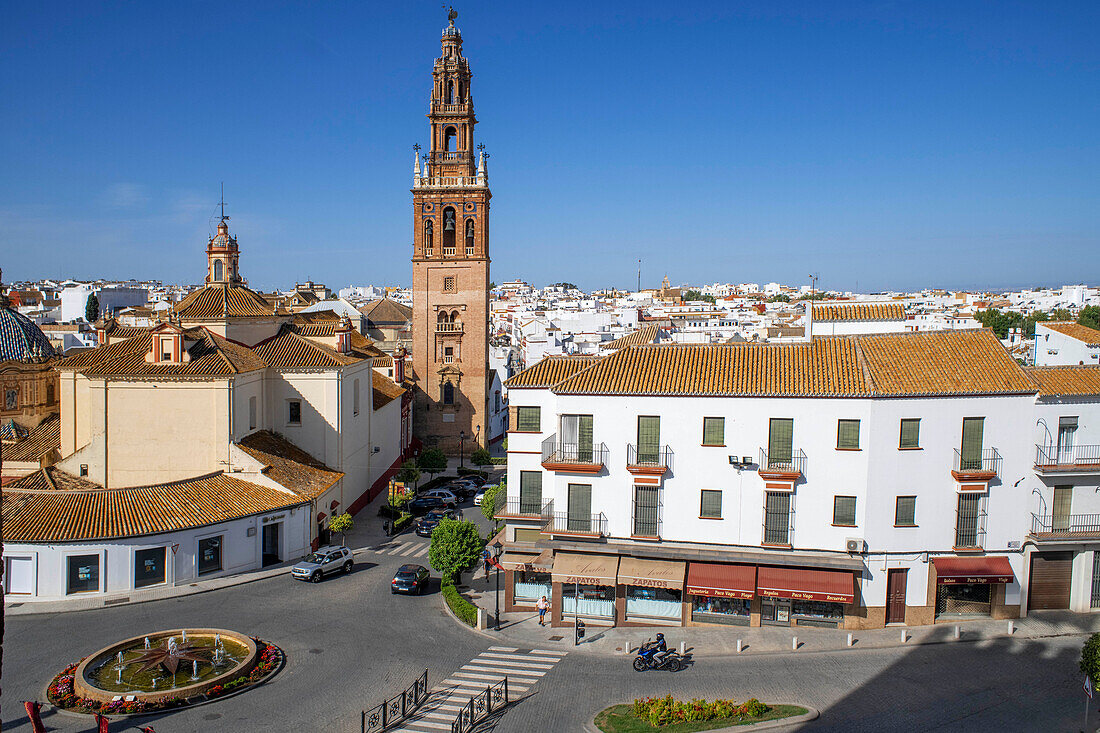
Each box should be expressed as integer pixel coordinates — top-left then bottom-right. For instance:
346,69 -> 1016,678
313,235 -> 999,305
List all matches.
0,0 -> 1100,291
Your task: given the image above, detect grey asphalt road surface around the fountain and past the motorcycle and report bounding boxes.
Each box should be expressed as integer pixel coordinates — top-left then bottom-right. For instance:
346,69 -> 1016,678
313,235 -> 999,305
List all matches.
0,510 -> 1100,733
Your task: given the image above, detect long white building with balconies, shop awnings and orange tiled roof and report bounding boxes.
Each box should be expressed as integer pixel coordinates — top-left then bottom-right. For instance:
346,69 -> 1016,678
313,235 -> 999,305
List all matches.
497,330 -> 1100,628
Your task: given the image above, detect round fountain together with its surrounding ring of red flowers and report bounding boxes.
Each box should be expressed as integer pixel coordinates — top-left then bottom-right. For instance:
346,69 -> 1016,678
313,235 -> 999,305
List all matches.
46,628 -> 283,714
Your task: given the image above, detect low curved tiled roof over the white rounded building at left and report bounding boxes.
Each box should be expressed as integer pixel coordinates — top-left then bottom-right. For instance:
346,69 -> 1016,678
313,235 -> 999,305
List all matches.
2,468 -> 306,543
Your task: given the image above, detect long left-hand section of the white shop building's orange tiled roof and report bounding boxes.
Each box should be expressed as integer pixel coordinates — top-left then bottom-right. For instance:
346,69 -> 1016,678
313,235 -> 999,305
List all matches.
553,338 -> 870,396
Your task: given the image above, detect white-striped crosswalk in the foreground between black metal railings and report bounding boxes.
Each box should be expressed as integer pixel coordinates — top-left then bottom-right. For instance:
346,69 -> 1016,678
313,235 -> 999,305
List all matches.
394,646 -> 567,733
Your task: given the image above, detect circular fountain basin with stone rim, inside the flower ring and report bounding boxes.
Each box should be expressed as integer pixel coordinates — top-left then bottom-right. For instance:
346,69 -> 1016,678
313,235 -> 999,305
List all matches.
73,628 -> 259,703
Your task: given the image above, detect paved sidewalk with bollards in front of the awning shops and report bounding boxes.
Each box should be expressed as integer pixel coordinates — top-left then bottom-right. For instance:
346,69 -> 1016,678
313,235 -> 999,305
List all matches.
463,571 -> 1100,656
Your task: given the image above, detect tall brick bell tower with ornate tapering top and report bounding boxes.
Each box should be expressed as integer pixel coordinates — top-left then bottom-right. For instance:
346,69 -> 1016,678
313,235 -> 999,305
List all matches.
413,10 -> 492,456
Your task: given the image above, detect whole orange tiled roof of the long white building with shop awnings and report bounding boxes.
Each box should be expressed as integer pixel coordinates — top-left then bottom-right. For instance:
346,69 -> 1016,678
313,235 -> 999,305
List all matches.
541,330 -> 1036,397
